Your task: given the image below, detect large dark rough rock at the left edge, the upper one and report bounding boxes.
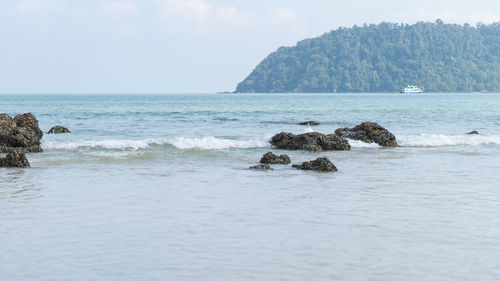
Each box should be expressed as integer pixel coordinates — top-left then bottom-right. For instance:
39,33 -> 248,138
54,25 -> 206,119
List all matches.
0,113 -> 43,153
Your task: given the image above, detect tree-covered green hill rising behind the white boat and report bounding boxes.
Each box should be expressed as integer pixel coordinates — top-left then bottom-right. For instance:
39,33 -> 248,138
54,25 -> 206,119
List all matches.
236,20 -> 500,92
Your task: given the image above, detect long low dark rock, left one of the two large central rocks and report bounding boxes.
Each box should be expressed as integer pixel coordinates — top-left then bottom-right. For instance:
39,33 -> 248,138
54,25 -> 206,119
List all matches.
269,132 -> 351,151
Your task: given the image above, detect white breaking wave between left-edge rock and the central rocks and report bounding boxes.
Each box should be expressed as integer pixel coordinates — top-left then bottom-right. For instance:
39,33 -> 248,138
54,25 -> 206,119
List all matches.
42,136 -> 270,150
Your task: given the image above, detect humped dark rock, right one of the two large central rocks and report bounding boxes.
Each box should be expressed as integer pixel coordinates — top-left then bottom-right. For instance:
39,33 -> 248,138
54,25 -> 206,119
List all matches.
335,122 -> 399,147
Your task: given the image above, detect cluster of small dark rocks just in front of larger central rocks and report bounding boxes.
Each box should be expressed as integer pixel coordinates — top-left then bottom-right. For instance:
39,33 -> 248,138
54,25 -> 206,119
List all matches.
250,152 -> 337,172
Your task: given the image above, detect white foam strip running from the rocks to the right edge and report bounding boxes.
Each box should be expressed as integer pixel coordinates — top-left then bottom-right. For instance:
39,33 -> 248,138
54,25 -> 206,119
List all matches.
396,134 -> 500,147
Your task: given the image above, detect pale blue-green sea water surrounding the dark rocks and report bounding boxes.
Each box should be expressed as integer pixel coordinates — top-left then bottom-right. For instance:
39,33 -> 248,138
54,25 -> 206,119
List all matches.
0,93 -> 500,281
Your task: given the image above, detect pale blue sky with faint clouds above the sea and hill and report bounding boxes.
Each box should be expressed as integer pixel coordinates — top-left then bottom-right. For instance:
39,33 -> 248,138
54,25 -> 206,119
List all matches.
0,0 -> 500,93
